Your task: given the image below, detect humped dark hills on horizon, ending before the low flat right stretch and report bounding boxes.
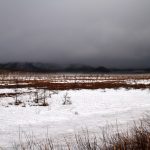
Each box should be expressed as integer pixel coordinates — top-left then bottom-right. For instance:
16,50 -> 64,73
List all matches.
0,63 -> 110,73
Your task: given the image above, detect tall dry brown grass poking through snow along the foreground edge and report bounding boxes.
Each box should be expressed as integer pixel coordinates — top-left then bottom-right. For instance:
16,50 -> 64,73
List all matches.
14,118 -> 150,150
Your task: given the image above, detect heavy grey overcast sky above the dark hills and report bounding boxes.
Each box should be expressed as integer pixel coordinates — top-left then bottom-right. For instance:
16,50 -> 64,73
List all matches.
0,0 -> 150,67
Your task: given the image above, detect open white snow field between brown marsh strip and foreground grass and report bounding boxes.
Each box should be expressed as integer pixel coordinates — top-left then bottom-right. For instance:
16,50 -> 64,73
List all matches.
0,88 -> 150,148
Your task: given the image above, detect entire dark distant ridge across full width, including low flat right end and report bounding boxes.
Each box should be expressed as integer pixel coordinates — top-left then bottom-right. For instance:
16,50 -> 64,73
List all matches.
0,62 -> 150,73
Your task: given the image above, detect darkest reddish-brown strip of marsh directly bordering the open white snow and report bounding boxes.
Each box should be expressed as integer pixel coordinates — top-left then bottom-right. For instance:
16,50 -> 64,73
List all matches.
0,80 -> 150,90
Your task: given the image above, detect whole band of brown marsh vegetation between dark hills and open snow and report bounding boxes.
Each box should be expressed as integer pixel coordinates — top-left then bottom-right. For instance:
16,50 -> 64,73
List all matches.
0,74 -> 150,90
